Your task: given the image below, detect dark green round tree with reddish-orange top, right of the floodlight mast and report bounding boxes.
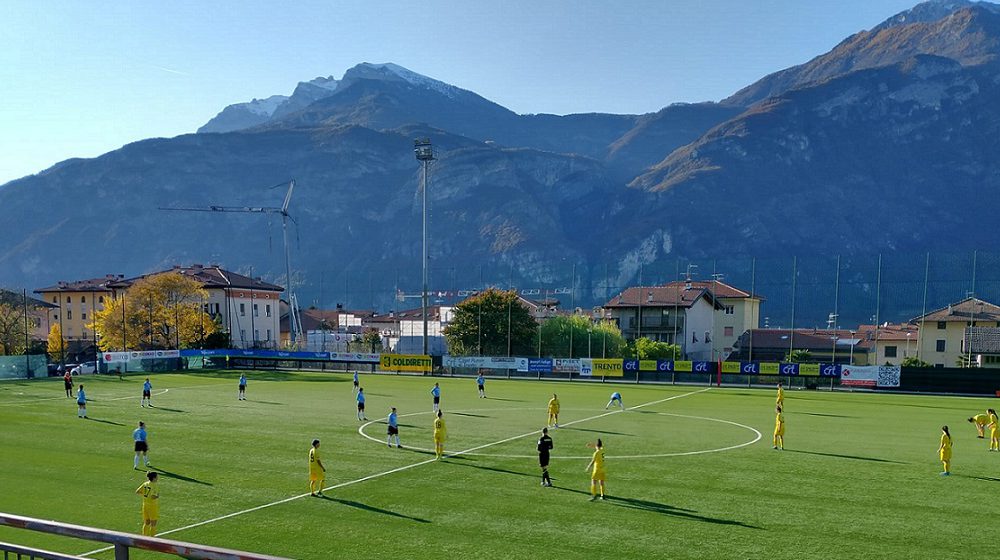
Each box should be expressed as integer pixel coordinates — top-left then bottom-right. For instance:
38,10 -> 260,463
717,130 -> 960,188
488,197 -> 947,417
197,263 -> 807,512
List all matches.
444,288 -> 538,356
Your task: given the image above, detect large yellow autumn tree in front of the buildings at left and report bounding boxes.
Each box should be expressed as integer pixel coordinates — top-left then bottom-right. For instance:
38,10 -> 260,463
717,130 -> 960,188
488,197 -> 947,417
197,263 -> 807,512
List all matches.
87,272 -> 218,350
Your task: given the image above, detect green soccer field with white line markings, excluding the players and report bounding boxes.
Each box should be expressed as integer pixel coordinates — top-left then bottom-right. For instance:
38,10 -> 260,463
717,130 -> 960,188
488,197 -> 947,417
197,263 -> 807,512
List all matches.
0,372 -> 1000,560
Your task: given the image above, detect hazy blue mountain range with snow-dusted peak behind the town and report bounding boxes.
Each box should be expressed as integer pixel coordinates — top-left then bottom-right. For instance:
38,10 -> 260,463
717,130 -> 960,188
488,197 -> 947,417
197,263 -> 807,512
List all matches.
0,1 -> 1000,326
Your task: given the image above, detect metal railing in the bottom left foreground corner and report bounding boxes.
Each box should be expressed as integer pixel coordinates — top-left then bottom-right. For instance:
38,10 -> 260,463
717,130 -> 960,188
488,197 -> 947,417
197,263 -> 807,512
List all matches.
0,513 -> 287,560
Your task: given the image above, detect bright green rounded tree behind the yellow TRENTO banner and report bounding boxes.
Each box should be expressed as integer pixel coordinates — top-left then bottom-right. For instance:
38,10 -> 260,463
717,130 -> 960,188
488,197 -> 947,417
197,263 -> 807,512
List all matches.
535,315 -> 625,358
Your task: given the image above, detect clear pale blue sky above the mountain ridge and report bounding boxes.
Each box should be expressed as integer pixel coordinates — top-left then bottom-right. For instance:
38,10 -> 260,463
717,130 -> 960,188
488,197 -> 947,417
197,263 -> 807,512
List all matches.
0,0 -> 916,184
